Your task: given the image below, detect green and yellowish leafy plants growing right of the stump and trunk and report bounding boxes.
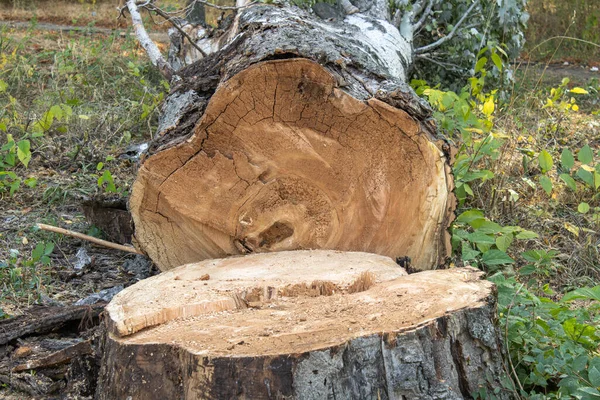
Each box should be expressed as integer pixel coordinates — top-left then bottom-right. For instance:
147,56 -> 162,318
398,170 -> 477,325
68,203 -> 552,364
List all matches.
412,52 -> 600,400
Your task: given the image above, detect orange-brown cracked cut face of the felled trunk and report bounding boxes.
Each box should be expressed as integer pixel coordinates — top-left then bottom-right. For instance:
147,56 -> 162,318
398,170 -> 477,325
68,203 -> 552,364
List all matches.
130,59 -> 453,270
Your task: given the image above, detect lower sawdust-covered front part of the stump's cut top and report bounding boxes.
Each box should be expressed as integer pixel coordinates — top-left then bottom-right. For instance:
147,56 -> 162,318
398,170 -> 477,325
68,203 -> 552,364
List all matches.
107,268 -> 495,357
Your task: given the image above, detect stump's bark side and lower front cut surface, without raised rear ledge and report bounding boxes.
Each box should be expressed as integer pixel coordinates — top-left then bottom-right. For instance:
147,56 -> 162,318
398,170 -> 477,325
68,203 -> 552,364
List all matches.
99,260 -> 508,400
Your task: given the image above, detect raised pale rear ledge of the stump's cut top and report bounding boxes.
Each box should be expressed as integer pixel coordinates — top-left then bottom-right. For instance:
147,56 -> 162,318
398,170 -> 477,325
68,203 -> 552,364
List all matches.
106,250 -> 406,337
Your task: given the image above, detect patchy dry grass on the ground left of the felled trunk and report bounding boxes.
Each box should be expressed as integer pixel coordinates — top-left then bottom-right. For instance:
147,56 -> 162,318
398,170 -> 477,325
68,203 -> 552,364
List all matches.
0,23 -> 167,314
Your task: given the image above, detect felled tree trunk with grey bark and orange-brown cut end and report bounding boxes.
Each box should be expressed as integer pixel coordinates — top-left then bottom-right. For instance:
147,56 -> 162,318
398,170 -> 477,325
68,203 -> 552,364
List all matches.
130,2 -> 454,270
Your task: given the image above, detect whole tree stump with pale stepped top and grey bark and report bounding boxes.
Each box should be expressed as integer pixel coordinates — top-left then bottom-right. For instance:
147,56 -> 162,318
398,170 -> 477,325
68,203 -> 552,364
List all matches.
98,251 -> 503,399
